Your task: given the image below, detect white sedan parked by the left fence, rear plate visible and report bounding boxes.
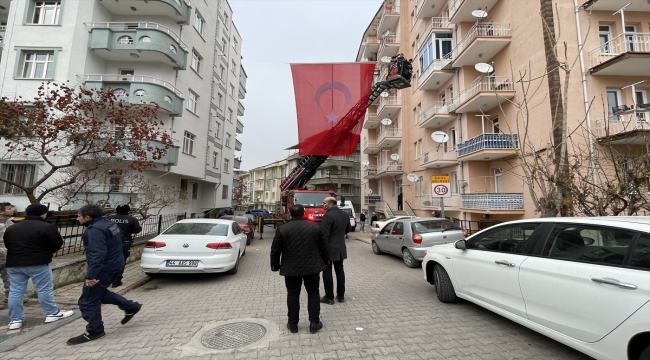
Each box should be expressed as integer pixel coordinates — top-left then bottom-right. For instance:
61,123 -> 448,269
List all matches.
140,219 -> 247,275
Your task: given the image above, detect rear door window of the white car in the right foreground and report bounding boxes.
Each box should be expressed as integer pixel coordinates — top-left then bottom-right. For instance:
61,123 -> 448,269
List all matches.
542,224 -> 636,265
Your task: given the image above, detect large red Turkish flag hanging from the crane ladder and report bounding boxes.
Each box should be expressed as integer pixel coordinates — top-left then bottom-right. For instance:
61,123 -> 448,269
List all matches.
291,63 -> 375,156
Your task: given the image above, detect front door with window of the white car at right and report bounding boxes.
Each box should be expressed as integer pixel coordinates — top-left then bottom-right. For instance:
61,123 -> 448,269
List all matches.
452,222 -> 542,318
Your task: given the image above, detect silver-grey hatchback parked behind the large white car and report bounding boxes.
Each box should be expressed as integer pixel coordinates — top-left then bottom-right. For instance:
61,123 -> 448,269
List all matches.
370,218 -> 465,268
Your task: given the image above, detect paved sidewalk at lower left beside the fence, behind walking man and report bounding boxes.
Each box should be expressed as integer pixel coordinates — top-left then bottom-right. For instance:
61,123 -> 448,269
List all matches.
0,260 -> 151,352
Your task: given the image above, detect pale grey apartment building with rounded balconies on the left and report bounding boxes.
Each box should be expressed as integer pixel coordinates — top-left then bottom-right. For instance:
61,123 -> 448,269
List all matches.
0,0 -> 246,216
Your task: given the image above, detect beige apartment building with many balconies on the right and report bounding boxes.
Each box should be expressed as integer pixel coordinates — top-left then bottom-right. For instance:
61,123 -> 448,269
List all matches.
356,0 -> 650,226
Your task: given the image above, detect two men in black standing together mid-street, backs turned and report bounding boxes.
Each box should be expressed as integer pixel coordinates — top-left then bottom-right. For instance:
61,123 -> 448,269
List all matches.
271,197 -> 352,334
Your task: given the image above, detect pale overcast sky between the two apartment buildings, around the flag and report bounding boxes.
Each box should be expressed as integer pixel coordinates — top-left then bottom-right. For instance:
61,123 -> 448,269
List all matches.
229,0 -> 383,170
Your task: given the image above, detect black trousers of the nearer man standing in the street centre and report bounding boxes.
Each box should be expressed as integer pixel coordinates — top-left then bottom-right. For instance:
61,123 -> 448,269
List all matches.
284,273 -> 320,325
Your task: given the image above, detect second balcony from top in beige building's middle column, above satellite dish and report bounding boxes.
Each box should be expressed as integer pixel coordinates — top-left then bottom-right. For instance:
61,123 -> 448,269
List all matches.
451,23 -> 510,67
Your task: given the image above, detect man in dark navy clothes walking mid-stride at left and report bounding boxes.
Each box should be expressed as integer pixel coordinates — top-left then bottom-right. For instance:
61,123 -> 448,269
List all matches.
67,205 -> 143,345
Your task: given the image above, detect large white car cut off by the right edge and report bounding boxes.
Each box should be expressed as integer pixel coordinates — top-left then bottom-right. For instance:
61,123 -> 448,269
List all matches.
422,216 -> 650,360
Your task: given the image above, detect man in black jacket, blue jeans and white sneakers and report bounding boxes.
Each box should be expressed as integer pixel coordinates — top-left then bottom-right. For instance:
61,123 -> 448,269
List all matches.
4,204 -> 73,330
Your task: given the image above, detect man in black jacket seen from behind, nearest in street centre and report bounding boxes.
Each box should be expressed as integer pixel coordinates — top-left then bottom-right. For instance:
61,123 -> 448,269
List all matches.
271,205 -> 328,334
